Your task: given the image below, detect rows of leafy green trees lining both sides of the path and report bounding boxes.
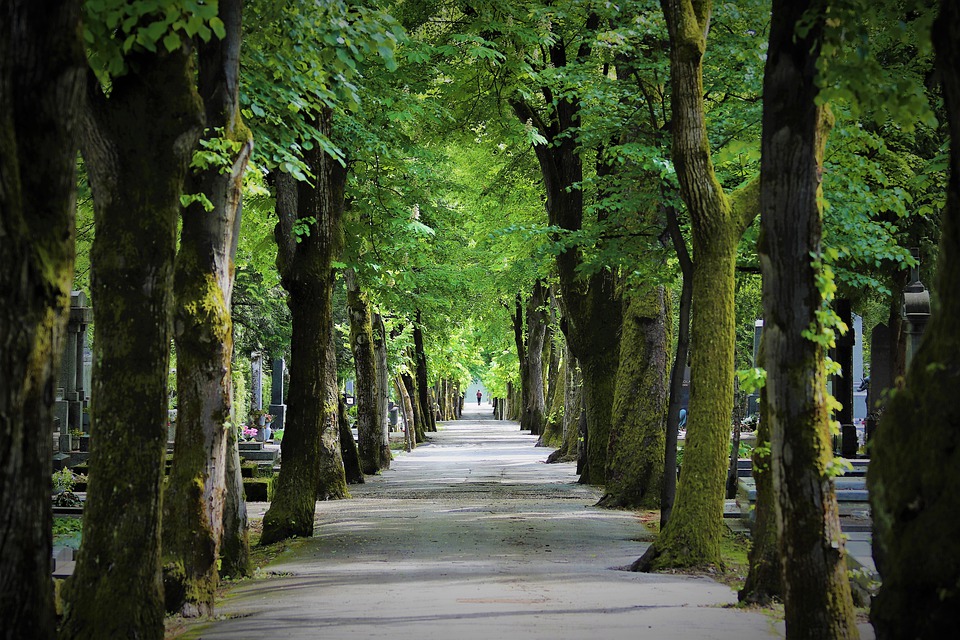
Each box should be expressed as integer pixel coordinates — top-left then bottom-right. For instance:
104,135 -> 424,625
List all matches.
0,0 -> 957,637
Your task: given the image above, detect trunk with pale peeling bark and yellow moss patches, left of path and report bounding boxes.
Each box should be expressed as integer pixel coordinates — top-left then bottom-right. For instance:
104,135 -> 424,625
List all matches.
161,0 -> 253,617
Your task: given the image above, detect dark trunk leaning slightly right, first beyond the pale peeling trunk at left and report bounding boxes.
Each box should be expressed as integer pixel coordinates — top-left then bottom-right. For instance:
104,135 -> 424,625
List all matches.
260,110 -> 347,545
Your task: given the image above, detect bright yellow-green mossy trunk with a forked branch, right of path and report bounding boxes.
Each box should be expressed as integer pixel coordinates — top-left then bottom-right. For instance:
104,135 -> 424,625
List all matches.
633,0 -> 759,570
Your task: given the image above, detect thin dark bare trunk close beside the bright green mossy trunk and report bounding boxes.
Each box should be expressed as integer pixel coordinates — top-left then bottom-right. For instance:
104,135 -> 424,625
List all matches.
660,207 -> 693,531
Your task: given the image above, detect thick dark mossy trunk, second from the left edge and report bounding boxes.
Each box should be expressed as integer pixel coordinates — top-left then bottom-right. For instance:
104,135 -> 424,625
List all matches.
61,46 -> 203,638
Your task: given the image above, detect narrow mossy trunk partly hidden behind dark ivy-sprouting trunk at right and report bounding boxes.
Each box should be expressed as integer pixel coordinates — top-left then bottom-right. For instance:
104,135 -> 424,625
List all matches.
737,350 -> 783,606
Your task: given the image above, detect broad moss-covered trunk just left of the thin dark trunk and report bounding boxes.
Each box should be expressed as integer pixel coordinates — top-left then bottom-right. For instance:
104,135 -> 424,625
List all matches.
600,287 -> 670,509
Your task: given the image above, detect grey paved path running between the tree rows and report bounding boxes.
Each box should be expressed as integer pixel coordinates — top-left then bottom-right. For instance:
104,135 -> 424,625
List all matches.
178,403 -> 872,640
